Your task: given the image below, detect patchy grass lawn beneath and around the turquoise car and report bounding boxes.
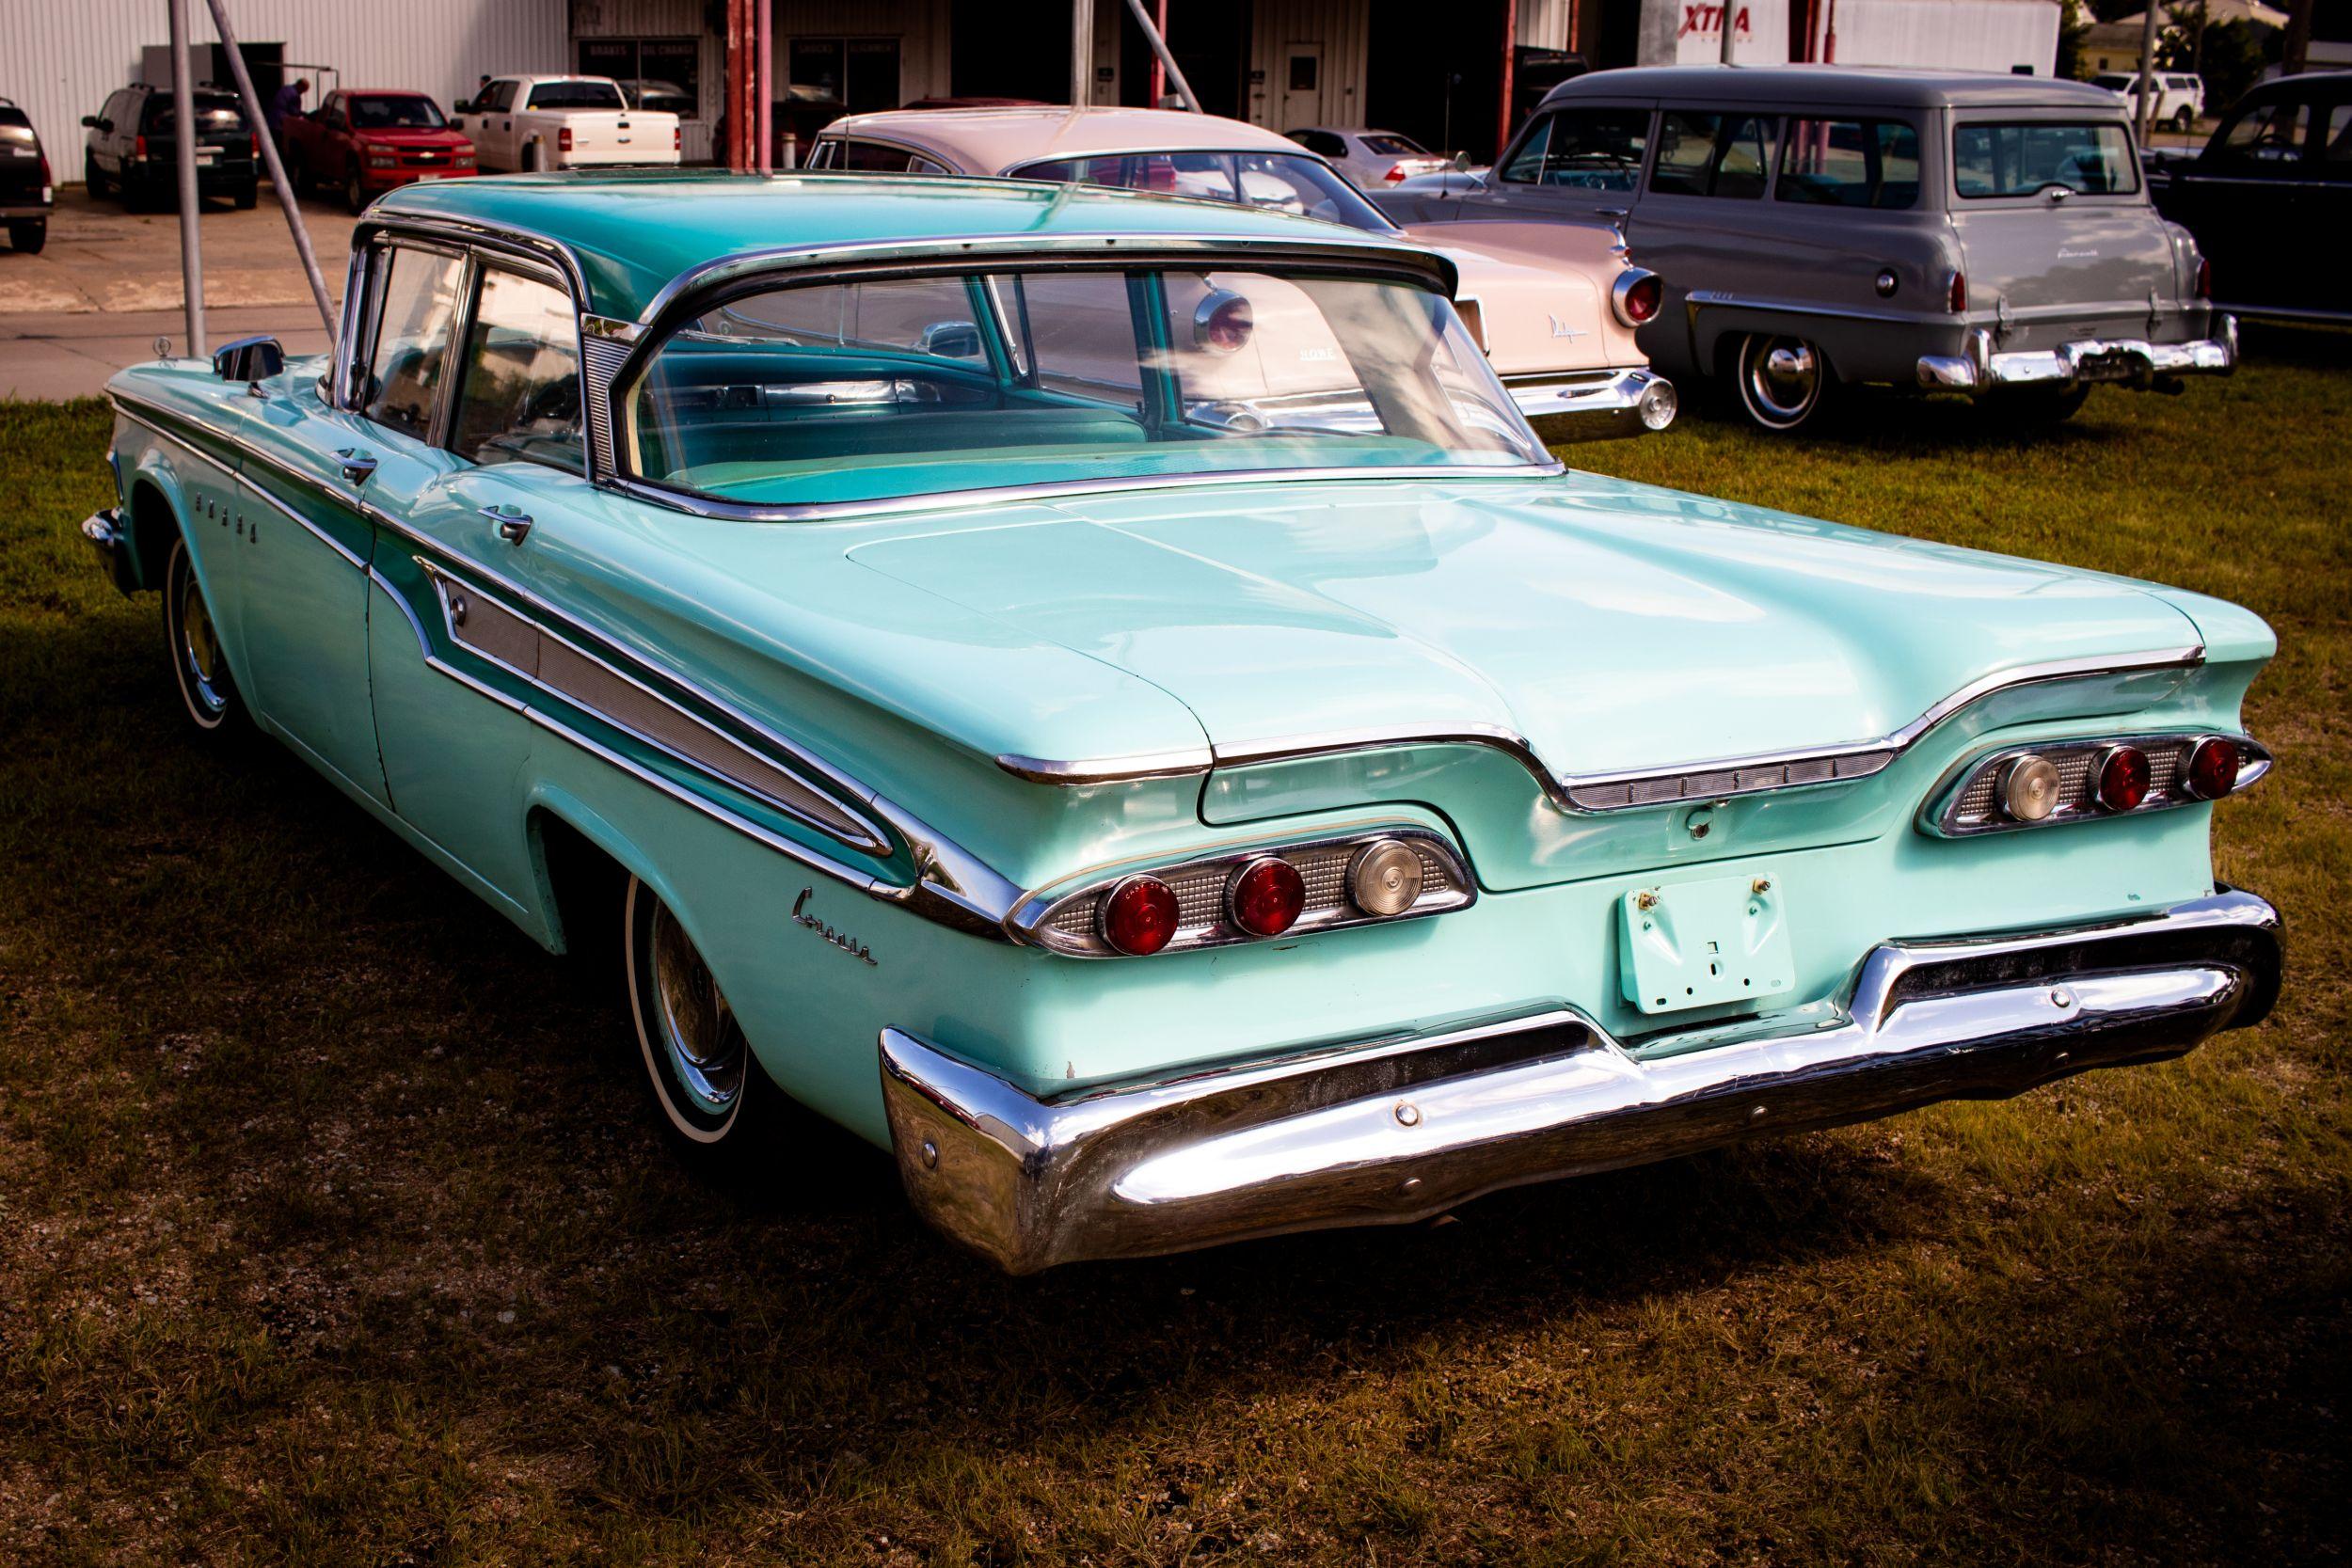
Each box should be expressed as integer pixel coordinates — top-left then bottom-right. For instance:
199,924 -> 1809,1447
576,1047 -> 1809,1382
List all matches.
0,350 -> 2352,1563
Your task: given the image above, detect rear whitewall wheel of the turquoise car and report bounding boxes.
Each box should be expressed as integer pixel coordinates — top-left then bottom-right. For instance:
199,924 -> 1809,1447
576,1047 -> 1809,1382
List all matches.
621,877 -> 767,1157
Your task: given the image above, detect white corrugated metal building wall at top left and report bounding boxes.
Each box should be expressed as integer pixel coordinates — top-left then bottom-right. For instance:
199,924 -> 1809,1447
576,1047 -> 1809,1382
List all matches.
0,0 -> 569,181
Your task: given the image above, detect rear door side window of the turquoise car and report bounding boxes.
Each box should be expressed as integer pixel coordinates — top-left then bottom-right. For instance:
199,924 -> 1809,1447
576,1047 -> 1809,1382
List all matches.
450,270 -> 581,472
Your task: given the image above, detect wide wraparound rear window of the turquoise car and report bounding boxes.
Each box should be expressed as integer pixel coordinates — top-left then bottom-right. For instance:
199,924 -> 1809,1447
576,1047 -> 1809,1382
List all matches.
621,268 -> 1548,505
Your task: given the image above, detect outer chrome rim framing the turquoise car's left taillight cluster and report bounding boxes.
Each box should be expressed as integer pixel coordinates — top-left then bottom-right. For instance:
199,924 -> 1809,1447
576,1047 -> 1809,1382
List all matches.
1005,818 -> 1477,959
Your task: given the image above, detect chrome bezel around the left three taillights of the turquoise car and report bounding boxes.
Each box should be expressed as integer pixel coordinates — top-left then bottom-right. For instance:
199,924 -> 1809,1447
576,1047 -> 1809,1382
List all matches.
1005,823 -> 1477,959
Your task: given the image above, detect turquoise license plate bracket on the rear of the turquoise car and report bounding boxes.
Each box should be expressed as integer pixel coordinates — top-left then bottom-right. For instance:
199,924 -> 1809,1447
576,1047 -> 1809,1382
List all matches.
1618,872 -> 1797,1013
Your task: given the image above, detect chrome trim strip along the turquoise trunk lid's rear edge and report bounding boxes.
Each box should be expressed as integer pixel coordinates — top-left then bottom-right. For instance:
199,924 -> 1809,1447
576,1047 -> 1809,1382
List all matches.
997,644 -> 2204,814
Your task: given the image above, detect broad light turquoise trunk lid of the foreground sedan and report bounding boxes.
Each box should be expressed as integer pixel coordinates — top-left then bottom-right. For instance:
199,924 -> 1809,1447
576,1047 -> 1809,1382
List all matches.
850,475 -> 2200,776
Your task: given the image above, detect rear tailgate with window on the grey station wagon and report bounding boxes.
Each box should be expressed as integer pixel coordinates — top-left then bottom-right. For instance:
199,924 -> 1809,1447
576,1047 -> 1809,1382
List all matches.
1952,108 -> 2181,350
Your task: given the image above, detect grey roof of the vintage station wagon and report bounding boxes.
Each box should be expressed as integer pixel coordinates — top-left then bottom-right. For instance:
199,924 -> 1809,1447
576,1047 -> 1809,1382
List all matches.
1543,66 -> 2115,113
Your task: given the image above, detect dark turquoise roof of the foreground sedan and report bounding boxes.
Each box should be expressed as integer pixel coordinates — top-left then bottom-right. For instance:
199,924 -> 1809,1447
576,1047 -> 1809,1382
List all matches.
372,168 -> 1454,320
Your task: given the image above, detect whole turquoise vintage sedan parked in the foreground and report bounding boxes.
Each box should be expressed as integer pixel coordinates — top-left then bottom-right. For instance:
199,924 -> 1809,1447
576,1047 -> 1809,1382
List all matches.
83,174 -> 2280,1270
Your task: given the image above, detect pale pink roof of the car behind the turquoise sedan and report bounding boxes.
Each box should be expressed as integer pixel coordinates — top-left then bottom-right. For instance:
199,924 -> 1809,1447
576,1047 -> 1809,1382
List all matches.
826,103 -> 1298,174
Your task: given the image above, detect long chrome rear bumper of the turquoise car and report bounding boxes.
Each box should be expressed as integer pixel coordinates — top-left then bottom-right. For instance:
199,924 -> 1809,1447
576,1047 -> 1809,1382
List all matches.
882,891 -> 2280,1275
